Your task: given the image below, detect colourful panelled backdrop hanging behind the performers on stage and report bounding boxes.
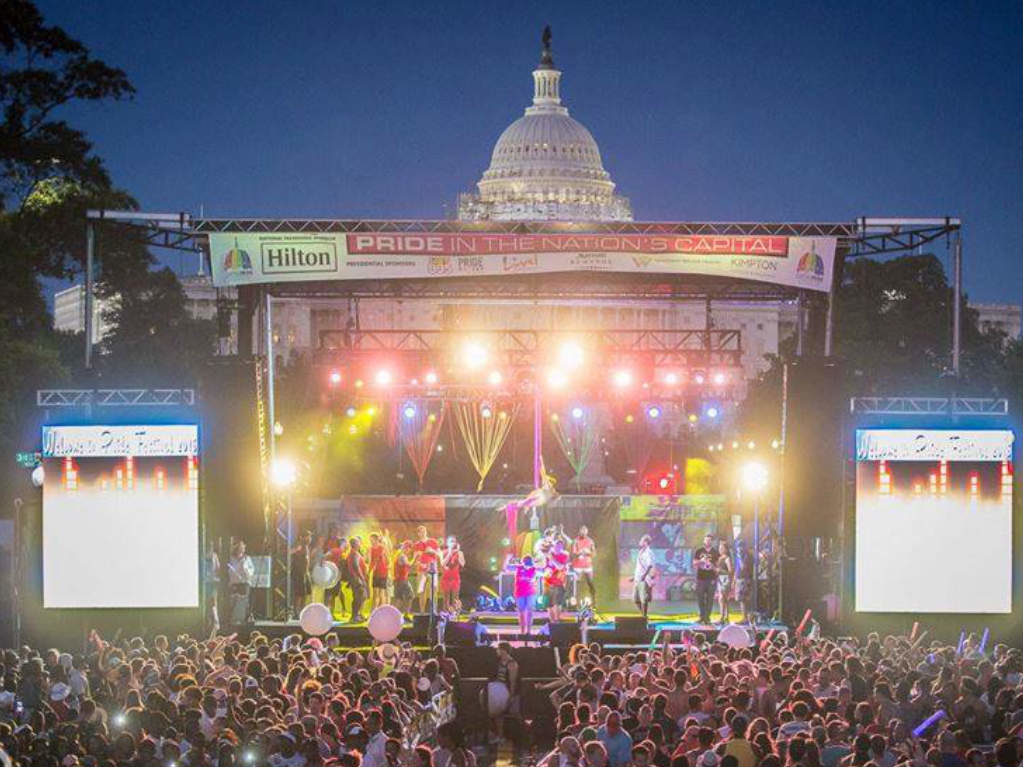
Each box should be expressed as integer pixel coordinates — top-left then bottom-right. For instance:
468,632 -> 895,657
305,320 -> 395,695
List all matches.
294,496 -> 725,606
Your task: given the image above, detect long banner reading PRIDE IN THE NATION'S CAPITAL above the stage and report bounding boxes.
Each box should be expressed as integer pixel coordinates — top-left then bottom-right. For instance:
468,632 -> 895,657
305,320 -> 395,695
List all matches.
209,231 -> 837,292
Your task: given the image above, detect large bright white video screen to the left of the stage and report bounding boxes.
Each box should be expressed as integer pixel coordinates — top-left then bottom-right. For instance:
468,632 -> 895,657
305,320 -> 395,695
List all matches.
43,424 -> 199,608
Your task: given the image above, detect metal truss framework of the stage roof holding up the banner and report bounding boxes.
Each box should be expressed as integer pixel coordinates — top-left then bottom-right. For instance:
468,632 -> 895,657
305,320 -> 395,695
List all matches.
85,211 -> 961,616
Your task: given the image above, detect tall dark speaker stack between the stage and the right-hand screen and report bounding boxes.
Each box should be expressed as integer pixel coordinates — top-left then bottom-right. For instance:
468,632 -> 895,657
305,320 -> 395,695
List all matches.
782,357 -> 844,539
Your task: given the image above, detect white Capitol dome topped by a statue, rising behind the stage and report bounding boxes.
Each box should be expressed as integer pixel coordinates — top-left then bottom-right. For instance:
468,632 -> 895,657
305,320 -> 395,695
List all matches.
459,28 -> 633,221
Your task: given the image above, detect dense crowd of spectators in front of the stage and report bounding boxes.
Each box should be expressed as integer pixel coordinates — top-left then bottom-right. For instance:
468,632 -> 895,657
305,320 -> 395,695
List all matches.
0,633 -> 1022,766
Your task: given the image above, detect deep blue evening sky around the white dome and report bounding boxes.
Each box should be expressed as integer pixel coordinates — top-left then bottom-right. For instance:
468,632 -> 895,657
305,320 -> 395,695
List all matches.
40,0 -> 1022,303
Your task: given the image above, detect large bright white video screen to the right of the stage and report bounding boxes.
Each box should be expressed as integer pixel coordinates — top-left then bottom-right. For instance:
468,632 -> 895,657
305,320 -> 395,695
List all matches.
854,429 -> 1014,613
